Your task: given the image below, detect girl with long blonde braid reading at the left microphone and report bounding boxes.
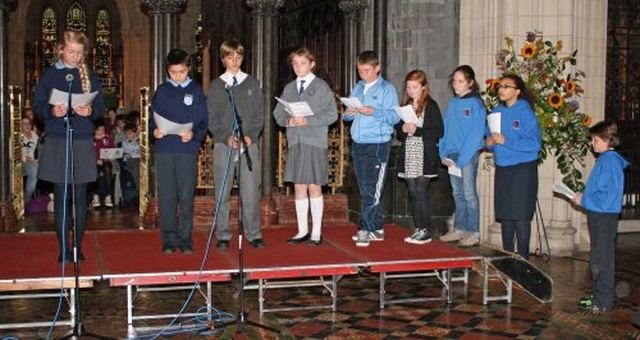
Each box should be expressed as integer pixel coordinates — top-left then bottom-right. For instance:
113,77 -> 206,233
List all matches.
33,31 -> 104,262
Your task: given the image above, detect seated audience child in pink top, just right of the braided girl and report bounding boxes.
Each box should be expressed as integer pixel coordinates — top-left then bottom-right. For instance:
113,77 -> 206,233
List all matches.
91,122 -> 116,208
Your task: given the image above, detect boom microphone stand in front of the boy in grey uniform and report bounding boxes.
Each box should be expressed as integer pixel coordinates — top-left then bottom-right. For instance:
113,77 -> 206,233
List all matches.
220,86 -> 278,334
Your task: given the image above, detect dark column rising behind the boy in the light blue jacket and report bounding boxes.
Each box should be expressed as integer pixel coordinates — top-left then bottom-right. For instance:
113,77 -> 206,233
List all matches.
338,0 -> 369,95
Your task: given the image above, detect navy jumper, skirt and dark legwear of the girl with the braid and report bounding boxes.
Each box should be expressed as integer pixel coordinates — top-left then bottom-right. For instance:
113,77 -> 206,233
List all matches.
33,61 -> 105,255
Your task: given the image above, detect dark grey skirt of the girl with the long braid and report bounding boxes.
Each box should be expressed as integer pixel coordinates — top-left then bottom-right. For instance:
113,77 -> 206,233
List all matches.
38,137 -> 98,184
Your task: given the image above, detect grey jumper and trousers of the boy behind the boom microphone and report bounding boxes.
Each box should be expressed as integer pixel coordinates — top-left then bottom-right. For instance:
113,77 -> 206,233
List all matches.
207,72 -> 264,242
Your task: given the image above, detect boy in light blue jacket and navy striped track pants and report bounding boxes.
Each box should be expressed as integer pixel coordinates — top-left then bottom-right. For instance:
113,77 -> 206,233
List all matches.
342,51 -> 400,247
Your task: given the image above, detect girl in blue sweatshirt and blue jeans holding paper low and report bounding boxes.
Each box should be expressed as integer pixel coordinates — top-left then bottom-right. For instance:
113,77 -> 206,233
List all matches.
439,65 -> 487,247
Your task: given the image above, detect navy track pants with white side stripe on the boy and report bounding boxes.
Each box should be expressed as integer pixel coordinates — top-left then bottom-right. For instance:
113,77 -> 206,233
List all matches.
351,142 -> 391,231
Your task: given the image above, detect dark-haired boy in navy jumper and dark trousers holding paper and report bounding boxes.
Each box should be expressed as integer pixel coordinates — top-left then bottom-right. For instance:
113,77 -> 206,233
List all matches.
150,49 -> 209,255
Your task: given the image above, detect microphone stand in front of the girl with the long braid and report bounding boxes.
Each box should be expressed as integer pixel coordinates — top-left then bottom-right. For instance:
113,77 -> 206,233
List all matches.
60,74 -> 115,340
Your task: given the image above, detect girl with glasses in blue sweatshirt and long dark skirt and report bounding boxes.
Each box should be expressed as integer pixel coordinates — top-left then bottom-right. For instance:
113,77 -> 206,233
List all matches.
486,74 -> 542,259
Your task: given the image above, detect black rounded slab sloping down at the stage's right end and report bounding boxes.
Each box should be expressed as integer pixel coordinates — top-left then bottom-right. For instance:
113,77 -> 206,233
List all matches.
489,256 -> 553,302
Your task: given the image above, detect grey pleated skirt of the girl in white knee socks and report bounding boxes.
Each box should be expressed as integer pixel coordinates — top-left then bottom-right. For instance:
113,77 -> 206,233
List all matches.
284,143 -> 328,185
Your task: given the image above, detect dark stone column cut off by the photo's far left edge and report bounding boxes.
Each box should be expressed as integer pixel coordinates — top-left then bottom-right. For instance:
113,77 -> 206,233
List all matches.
0,0 -> 15,231
